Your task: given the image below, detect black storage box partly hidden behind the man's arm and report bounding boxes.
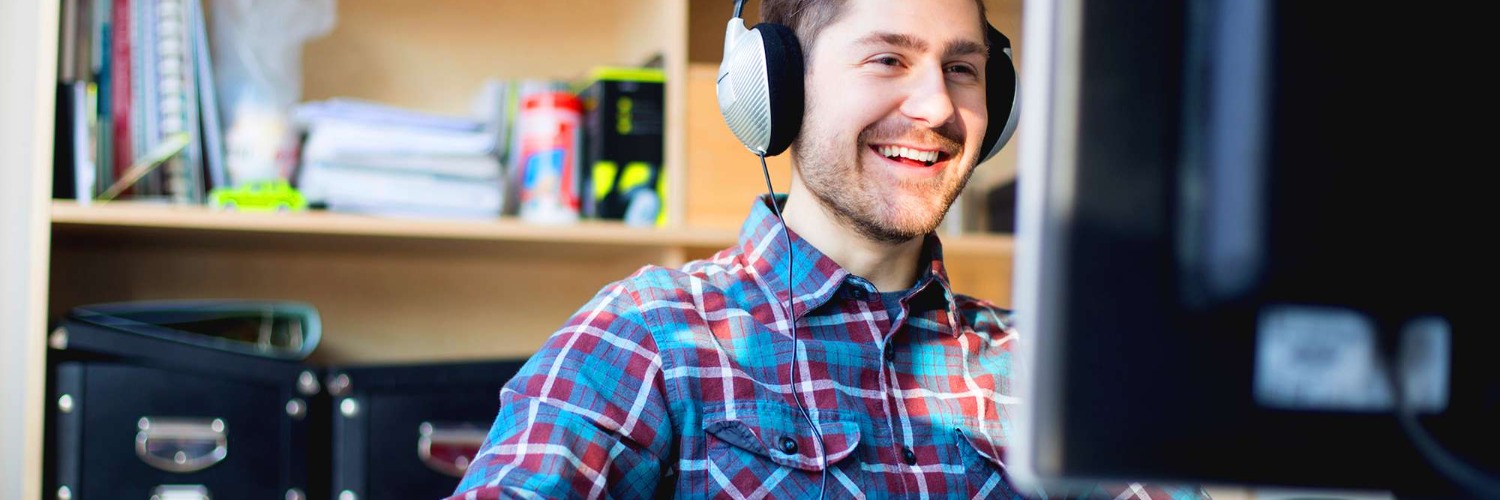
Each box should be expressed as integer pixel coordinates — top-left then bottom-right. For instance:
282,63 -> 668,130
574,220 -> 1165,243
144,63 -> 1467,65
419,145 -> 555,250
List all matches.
326,360 -> 524,500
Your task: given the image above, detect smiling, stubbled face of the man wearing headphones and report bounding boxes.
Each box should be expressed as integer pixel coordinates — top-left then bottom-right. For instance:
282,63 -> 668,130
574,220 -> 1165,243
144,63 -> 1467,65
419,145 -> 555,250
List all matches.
794,0 -> 987,242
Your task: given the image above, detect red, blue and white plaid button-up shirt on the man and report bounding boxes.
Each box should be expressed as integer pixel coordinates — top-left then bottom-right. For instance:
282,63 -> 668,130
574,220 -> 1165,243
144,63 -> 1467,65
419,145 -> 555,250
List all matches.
453,198 -> 1200,498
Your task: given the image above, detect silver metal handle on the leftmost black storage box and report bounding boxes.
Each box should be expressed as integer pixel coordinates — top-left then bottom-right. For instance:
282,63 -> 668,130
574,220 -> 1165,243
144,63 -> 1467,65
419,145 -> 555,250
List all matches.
135,417 -> 230,473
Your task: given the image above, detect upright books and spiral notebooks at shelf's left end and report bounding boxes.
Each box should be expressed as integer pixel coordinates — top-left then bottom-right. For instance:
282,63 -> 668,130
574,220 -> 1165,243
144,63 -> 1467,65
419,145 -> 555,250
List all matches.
53,0 -> 225,203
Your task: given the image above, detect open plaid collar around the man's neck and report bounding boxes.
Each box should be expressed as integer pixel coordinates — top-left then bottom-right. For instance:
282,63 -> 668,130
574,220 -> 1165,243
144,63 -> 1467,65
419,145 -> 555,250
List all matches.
740,195 -> 959,336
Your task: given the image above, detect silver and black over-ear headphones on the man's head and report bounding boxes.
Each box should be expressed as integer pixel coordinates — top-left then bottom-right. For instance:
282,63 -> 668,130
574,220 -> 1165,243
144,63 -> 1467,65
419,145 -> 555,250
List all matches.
714,0 -> 1020,162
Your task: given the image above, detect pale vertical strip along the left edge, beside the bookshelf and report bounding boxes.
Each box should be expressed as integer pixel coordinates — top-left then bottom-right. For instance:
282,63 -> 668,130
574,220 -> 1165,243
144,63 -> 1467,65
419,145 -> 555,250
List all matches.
0,0 -> 59,492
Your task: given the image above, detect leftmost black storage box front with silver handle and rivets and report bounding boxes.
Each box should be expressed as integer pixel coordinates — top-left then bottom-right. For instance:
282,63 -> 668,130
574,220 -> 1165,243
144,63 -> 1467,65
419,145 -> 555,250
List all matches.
57,362 -> 316,498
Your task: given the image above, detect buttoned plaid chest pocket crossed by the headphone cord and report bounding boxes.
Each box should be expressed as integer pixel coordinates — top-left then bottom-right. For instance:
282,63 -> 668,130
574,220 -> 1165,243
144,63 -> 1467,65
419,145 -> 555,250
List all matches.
704,401 -> 860,498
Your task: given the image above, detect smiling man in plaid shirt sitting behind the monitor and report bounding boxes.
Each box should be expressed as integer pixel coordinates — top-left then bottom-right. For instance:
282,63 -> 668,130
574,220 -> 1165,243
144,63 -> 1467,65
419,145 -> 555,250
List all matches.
455,0 -> 1197,498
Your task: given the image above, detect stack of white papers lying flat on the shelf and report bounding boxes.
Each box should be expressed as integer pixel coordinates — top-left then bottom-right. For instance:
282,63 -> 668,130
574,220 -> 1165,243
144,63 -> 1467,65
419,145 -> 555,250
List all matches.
296,99 -> 506,218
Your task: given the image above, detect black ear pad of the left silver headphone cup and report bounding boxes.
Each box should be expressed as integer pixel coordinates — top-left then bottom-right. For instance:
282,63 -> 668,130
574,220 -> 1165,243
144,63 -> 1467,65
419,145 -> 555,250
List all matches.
752,23 -> 804,156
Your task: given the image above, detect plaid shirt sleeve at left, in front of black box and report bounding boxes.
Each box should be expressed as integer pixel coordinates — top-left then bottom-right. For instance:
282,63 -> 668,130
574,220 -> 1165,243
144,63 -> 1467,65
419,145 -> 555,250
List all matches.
450,277 -> 672,498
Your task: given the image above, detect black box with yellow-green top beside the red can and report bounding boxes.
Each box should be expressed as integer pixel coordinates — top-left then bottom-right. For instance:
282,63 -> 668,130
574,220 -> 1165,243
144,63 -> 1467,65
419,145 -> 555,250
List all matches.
579,68 -> 666,225
